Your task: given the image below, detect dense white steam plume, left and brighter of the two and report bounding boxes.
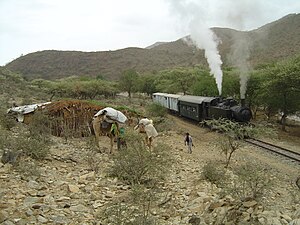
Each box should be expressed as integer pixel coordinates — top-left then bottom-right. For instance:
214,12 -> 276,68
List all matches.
169,0 -> 223,95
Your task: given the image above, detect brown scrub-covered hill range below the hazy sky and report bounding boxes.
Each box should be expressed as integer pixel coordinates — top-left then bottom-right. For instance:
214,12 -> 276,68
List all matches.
6,14 -> 300,80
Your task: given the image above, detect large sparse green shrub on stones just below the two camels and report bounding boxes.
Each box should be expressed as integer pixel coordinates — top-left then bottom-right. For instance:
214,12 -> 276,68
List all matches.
109,129 -> 171,184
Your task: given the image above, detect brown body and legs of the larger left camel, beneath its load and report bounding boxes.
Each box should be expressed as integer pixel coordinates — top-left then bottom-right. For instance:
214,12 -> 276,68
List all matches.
93,116 -> 119,153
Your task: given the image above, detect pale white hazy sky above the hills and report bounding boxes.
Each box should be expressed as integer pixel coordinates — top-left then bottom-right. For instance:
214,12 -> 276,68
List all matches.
0,0 -> 300,66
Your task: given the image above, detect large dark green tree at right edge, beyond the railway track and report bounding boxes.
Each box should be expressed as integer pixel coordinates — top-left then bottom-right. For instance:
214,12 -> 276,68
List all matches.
263,56 -> 300,131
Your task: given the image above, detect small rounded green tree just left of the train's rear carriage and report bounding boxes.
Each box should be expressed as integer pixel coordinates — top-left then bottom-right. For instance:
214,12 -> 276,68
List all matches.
119,69 -> 139,98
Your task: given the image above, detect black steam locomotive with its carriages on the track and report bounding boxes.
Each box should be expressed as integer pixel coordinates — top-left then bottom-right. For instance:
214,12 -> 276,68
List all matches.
152,93 -> 252,123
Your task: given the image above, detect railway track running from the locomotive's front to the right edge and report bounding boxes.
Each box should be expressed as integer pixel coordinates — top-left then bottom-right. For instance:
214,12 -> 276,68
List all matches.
244,138 -> 300,163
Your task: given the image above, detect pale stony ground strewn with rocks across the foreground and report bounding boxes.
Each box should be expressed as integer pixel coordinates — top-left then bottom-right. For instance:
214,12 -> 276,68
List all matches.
0,117 -> 300,225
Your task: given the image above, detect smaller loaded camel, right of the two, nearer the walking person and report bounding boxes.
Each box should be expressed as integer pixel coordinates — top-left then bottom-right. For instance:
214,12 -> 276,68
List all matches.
134,118 -> 158,149
